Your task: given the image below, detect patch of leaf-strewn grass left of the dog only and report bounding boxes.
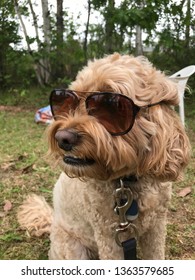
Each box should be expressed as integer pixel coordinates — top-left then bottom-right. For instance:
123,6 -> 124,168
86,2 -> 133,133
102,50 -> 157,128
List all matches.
0,90 -> 59,259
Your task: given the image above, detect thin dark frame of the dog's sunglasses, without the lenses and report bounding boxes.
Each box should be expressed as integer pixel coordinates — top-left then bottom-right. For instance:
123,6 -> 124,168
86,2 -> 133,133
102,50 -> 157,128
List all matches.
49,88 -> 161,136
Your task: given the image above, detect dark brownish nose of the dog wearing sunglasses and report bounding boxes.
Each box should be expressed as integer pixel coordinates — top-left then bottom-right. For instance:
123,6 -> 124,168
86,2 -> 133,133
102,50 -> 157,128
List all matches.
55,130 -> 78,151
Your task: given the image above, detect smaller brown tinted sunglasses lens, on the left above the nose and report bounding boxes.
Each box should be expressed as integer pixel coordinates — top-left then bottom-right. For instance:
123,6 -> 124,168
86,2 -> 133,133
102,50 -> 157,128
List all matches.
50,89 -> 79,117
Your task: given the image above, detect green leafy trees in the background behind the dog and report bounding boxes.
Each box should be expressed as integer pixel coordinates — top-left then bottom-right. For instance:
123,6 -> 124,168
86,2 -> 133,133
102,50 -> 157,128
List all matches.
0,0 -> 195,89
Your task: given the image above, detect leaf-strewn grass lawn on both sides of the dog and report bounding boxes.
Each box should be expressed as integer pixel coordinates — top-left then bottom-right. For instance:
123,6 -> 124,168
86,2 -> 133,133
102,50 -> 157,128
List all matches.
0,89 -> 195,260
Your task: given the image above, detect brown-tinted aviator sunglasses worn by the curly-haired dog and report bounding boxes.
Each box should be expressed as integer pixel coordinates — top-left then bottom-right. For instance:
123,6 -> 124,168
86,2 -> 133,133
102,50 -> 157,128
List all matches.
50,89 -> 159,136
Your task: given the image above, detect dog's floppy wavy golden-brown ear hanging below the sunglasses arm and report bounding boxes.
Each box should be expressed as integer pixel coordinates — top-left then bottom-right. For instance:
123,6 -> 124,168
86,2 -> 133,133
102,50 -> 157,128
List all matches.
138,103 -> 190,181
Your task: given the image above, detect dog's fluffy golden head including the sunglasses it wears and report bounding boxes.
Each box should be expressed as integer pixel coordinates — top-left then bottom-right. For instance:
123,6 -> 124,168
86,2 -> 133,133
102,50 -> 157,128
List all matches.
48,53 -> 190,181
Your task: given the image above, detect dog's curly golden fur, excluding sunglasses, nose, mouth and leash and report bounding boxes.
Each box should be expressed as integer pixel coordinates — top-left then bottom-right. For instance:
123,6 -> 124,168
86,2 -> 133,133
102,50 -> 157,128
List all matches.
18,53 -> 190,259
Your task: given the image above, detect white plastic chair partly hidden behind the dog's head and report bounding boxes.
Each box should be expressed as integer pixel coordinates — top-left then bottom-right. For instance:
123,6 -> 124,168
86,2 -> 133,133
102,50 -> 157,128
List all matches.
170,65 -> 195,125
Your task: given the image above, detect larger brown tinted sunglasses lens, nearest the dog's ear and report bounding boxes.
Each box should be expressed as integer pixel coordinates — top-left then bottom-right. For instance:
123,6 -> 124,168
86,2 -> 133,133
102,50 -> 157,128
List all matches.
86,93 -> 134,135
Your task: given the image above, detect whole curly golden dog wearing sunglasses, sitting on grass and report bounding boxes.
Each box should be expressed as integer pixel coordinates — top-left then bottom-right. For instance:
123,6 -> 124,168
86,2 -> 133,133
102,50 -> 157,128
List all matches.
18,53 -> 190,260
